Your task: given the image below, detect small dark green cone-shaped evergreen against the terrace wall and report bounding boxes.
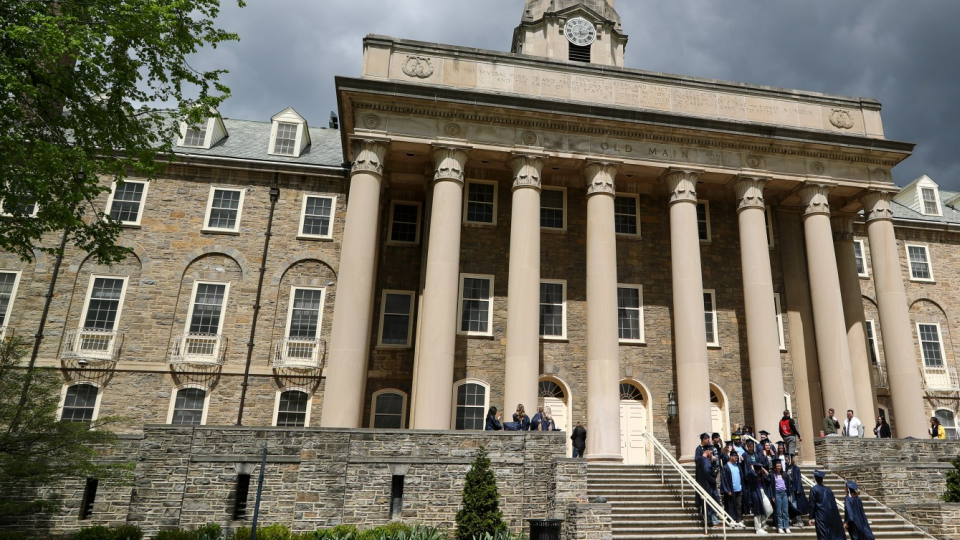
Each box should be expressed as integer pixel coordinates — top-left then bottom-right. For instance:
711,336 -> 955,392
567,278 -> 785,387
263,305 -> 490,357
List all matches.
456,446 -> 507,540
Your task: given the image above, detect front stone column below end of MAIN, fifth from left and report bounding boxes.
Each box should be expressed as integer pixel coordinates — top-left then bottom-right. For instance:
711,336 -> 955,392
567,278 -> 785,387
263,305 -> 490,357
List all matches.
664,170 -> 708,462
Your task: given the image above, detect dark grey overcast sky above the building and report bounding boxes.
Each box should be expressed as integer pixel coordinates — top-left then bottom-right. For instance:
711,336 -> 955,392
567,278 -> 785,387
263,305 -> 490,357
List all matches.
196,0 -> 960,190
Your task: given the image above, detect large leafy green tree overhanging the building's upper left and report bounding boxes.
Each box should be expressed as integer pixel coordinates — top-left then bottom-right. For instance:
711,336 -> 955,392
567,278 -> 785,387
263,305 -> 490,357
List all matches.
0,0 -> 244,263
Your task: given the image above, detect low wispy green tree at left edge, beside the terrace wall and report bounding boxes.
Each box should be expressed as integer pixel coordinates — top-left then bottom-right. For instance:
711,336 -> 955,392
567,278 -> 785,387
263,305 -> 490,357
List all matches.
0,337 -> 133,518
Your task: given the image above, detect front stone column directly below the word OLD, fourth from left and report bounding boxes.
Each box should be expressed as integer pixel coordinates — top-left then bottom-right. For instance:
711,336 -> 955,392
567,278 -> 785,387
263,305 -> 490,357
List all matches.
583,162 -> 623,462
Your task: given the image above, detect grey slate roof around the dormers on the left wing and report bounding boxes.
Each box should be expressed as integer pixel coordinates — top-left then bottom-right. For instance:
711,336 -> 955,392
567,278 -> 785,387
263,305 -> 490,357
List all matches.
174,118 -> 343,168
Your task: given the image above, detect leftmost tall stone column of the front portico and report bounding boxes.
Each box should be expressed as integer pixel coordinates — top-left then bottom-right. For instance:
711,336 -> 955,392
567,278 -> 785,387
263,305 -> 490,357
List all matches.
320,139 -> 388,428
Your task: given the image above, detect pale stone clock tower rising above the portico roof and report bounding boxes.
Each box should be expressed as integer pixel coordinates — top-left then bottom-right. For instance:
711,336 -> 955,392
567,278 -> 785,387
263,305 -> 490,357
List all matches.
511,0 -> 627,67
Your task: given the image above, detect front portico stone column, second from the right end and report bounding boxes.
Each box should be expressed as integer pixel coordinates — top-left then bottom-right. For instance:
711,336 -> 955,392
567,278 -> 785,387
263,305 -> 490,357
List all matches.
799,183 -> 857,415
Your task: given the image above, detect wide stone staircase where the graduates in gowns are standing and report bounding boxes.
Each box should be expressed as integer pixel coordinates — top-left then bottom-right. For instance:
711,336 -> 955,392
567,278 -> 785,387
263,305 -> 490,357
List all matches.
587,464 -> 932,540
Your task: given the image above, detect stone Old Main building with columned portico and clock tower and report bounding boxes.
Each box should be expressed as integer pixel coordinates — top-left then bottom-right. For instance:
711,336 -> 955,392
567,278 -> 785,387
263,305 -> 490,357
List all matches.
0,0 -> 960,478
